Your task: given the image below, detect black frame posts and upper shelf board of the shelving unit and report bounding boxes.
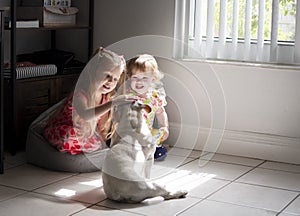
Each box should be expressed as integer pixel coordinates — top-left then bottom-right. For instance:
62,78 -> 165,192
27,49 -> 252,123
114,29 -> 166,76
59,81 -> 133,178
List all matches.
6,0 -> 94,155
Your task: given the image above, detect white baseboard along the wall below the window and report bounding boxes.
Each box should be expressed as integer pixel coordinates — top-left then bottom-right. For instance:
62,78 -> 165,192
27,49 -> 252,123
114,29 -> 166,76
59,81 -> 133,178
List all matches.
168,124 -> 300,164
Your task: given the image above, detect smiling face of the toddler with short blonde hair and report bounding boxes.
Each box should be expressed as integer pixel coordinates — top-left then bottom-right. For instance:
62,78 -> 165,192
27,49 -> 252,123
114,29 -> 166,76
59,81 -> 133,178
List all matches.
130,70 -> 153,95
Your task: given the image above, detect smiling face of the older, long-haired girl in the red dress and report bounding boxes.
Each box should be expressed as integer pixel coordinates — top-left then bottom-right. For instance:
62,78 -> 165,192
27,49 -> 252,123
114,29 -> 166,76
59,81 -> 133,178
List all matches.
96,66 -> 123,94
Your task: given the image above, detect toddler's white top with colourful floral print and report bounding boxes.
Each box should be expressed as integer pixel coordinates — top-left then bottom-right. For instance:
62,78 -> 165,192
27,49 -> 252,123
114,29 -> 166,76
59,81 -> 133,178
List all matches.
127,88 -> 167,130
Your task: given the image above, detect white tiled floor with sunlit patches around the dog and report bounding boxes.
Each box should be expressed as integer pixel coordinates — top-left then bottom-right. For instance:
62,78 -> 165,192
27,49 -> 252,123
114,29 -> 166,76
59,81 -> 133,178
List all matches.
0,149 -> 300,216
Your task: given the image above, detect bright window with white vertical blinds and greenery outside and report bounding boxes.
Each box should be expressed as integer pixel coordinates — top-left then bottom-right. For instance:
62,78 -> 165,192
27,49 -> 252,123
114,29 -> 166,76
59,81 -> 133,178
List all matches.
174,0 -> 300,64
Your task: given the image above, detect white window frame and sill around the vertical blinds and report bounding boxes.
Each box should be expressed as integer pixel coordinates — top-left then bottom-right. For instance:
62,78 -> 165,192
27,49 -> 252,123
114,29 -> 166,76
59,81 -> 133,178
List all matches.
173,0 -> 300,67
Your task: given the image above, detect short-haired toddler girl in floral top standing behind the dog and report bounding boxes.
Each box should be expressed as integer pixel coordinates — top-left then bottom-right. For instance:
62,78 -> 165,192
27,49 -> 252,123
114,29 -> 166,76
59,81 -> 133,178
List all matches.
127,54 -> 169,160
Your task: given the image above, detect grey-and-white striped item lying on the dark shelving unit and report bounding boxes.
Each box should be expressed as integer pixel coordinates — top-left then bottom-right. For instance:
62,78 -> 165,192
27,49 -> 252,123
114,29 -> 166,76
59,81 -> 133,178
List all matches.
4,64 -> 57,79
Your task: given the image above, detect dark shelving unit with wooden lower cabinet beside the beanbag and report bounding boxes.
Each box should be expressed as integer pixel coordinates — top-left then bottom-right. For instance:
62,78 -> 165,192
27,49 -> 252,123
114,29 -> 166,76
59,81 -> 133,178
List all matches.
1,0 -> 94,155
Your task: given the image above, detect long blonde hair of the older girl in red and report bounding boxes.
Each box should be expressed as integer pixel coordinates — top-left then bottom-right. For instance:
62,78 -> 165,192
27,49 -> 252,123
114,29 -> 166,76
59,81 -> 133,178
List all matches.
73,47 -> 126,141
